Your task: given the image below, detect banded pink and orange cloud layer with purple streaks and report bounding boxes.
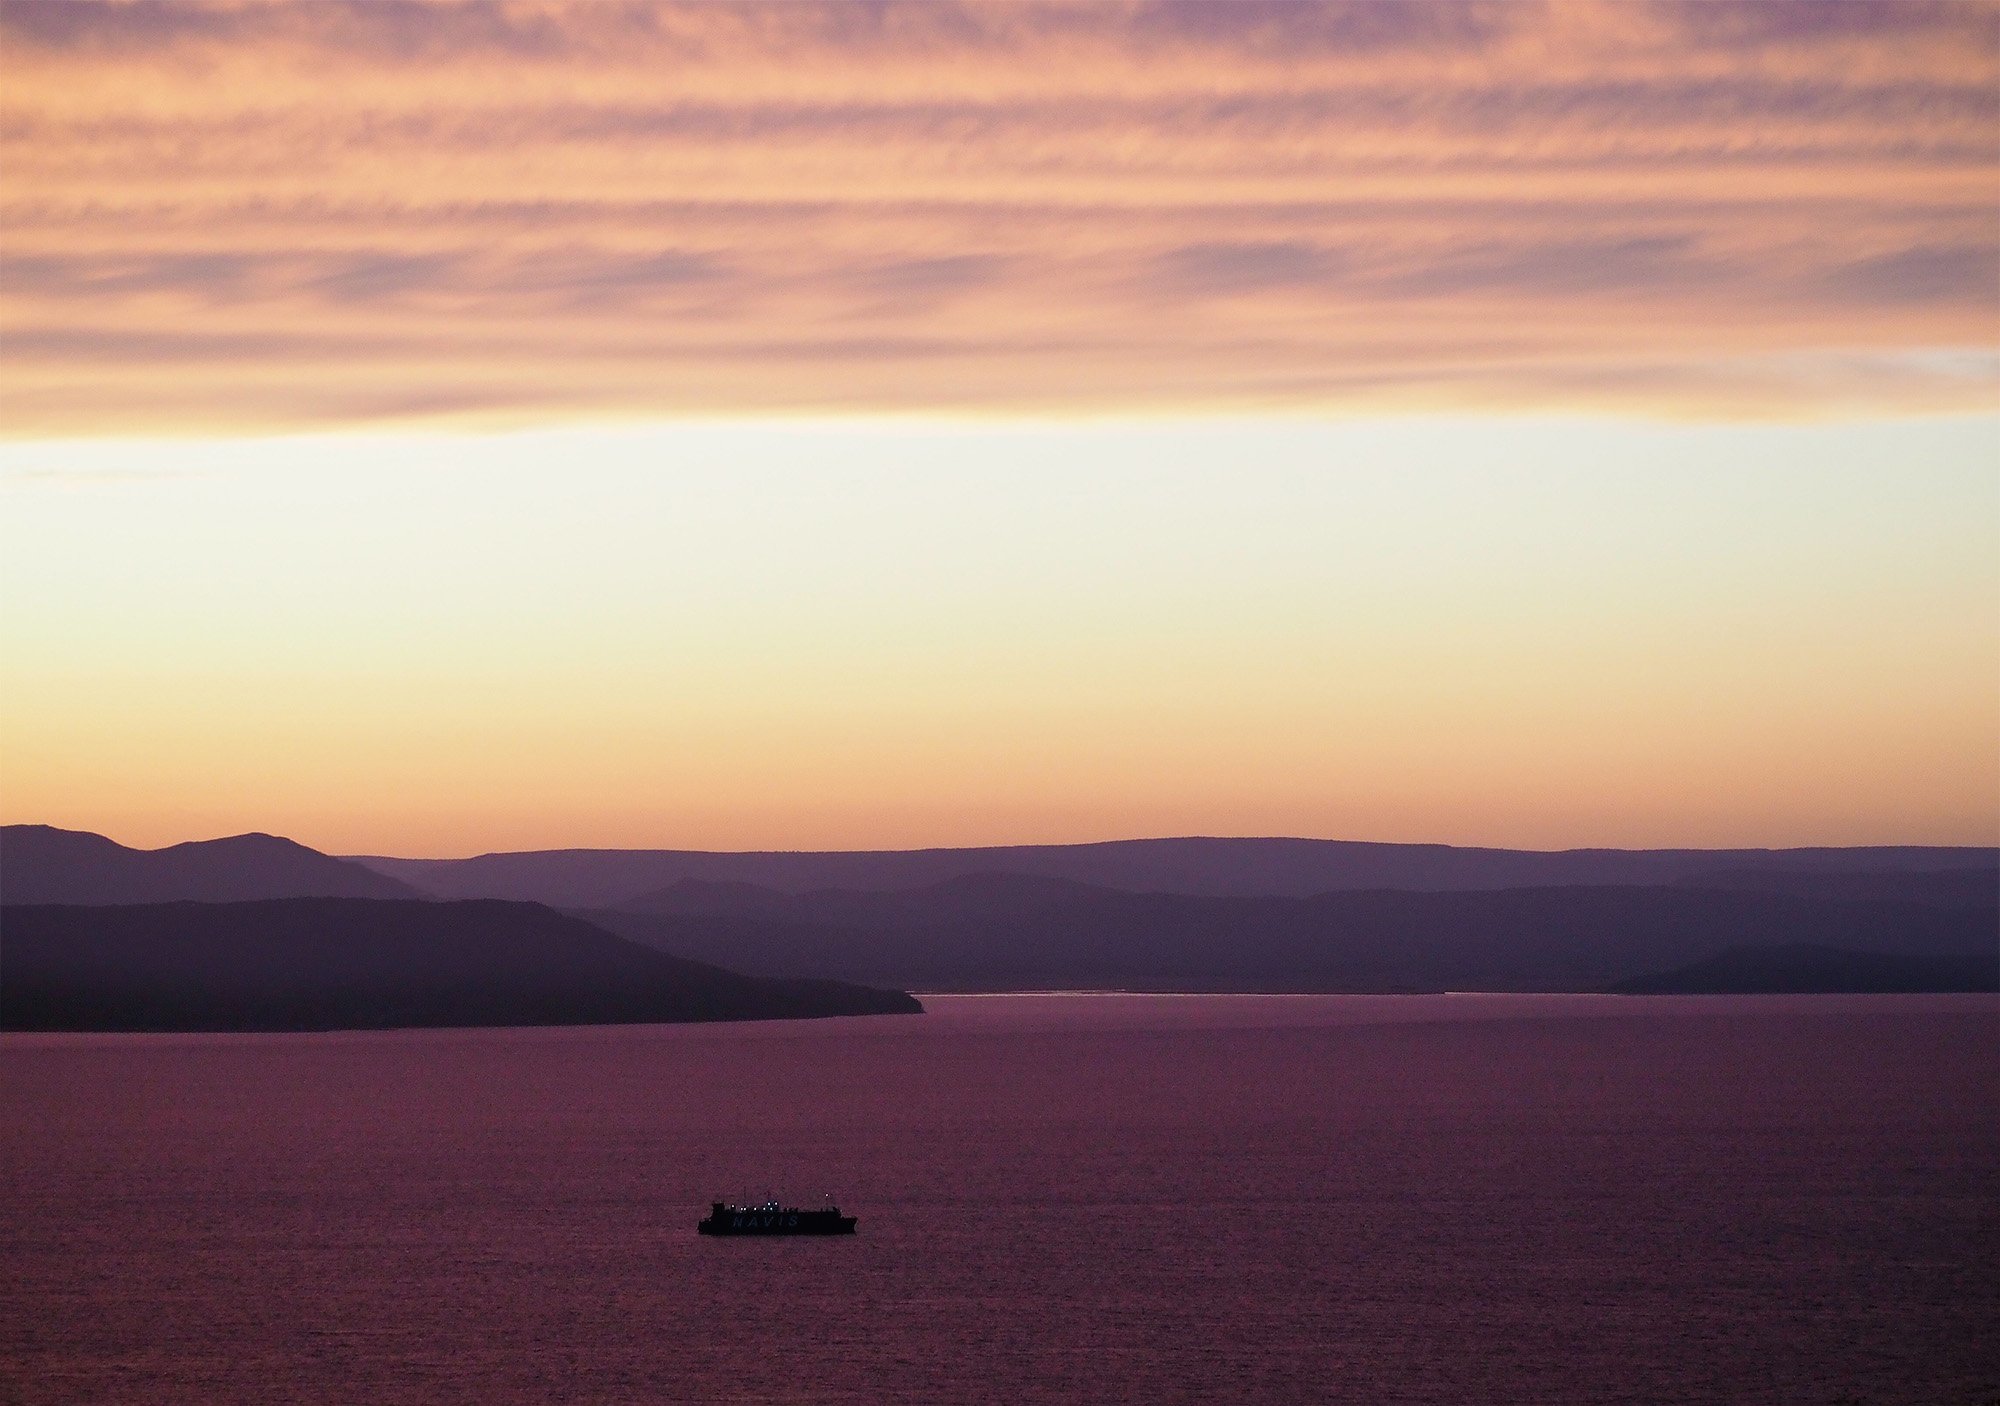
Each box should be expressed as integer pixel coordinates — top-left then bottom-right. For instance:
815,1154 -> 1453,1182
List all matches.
0,0 -> 2000,434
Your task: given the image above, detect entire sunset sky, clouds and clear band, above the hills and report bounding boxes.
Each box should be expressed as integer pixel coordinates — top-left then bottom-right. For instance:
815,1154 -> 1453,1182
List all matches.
0,0 -> 2000,856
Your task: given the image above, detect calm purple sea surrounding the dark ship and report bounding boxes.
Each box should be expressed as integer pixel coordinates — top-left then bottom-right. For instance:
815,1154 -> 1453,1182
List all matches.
0,996 -> 2000,1406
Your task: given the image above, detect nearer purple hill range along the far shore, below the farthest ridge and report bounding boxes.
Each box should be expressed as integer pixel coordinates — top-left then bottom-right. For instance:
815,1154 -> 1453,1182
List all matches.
588,874 -> 2000,992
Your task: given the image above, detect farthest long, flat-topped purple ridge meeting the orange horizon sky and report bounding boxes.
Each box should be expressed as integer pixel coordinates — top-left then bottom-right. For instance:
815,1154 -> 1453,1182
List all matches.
354,836 -> 2000,908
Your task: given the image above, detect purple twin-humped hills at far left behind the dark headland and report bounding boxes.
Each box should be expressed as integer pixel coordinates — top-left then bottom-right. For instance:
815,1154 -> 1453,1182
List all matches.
0,826 -> 428,904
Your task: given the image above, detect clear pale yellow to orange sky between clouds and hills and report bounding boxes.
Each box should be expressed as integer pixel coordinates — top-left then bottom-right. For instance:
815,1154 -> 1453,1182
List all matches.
0,420 -> 2000,854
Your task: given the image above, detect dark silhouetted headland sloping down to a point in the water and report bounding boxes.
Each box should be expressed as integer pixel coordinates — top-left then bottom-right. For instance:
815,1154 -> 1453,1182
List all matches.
0,898 -> 922,1030
